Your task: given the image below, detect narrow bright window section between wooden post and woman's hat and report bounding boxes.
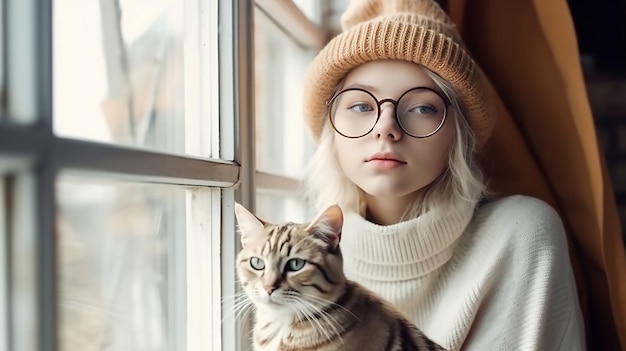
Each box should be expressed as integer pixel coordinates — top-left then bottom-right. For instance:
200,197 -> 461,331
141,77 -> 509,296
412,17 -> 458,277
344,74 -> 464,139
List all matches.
254,1 -> 325,221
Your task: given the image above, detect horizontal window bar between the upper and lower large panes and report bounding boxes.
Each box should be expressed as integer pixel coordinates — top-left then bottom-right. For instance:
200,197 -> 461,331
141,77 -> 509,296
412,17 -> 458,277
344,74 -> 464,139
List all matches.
0,124 -> 239,187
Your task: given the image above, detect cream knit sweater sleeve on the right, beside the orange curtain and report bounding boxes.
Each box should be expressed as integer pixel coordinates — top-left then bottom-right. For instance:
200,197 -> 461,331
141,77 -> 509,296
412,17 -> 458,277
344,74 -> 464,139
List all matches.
461,196 -> 585,351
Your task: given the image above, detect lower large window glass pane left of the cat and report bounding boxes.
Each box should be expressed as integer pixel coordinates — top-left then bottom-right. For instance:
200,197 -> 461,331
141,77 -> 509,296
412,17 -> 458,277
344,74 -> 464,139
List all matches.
56,175 -> 202,351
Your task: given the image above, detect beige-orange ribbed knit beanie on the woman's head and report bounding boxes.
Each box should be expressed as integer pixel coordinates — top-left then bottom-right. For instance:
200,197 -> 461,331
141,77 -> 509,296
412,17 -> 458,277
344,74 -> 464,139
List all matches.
304,0 -> 495,148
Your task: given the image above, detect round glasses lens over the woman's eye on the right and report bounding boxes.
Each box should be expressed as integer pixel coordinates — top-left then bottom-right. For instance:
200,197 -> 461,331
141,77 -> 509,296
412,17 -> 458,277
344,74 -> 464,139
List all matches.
396,88 -> 446,137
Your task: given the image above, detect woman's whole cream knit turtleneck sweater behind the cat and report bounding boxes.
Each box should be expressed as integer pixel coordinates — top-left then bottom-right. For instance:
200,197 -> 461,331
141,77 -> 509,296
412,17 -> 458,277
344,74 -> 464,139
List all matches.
341,196 -> 585,351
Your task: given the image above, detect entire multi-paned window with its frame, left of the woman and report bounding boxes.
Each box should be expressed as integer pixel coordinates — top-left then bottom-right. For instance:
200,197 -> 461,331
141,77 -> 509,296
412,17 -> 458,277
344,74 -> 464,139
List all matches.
0,0 -> 325,351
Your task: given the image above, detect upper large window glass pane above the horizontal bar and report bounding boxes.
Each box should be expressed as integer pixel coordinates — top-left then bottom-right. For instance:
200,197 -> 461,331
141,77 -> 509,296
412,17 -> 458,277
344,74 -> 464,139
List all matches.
53,0 -> 210,156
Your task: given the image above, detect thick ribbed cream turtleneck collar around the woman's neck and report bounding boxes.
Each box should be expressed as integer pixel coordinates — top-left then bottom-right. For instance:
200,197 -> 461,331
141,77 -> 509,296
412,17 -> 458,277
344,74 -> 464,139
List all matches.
341,202 -> 474,281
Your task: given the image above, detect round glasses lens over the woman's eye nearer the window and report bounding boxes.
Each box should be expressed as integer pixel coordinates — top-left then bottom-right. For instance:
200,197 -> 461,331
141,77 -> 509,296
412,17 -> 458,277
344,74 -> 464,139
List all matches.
330,90 -> 378,138
